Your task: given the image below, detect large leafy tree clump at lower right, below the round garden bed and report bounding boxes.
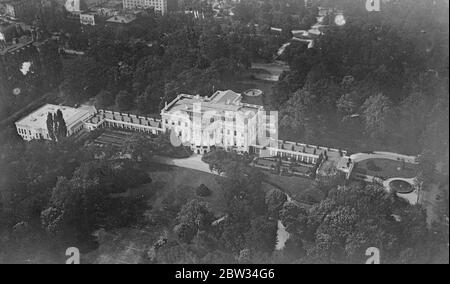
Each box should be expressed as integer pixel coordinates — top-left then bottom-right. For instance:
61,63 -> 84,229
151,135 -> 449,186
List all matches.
302,185 -> 440,263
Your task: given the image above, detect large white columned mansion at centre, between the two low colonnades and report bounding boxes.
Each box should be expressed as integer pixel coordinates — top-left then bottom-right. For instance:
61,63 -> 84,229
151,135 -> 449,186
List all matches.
161,90 -> 278,154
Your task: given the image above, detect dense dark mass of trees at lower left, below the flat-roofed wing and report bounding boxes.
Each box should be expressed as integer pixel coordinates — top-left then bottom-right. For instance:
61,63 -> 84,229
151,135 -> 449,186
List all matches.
0,140 -> 151,262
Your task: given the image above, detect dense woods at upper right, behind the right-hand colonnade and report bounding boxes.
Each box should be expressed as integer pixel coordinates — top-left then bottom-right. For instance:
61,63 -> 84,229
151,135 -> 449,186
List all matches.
271,0 -> 448,169
